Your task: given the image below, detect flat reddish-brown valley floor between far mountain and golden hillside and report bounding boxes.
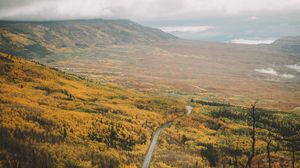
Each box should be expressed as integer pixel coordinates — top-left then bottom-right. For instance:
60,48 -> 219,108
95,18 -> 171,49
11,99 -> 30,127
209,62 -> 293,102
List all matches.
40,41 -> 300,111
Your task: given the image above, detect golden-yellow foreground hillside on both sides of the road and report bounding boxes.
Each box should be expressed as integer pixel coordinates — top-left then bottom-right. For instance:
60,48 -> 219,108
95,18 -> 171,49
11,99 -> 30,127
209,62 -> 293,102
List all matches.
0,53 -> 300,168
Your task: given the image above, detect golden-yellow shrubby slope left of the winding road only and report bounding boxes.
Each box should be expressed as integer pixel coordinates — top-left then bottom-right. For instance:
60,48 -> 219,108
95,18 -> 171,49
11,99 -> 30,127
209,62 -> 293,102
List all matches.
0,53 -> 184,167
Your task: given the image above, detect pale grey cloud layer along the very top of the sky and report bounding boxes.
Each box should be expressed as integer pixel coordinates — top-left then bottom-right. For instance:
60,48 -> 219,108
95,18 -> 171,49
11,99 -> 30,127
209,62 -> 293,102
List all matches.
0,0 -> 300,21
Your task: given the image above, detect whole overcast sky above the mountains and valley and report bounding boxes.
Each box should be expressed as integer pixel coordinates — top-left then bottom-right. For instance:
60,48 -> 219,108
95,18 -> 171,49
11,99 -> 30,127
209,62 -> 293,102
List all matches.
0,0 -> 300,44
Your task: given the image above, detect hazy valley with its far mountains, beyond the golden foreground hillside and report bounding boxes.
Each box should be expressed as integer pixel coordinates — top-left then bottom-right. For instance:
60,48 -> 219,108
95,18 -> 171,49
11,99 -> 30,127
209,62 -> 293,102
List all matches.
0,20 -> 300,111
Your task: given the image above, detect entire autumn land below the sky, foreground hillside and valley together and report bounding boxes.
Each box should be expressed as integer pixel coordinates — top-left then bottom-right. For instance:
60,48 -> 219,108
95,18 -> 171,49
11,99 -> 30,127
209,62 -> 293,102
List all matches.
0,19 -> 300,168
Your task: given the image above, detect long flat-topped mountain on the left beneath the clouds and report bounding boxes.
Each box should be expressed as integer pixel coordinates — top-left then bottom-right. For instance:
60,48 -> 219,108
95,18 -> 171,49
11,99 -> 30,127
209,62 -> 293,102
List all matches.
0,19 -> 176,57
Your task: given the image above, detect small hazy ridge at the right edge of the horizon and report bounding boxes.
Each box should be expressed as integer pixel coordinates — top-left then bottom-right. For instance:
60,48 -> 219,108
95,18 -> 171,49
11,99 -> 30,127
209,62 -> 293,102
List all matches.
272,36 -> 300,55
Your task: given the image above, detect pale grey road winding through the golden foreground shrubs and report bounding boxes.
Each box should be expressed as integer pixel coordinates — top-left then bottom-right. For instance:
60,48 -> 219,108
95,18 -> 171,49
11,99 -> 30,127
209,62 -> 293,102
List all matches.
142,106 -> 193,168
